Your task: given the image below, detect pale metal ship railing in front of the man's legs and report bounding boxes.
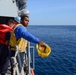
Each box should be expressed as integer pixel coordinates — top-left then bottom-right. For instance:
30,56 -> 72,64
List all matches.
11,42 -> 35,75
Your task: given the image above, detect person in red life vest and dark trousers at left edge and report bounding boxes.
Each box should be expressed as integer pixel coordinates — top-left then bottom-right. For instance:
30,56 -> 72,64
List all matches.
0,20 -> 14,75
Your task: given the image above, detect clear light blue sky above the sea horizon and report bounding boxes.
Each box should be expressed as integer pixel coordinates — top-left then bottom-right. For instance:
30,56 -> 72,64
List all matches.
26,0 -> 76,25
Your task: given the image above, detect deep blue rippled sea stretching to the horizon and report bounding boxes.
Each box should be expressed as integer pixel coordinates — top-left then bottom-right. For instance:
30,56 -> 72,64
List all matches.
27,25 -> 76,75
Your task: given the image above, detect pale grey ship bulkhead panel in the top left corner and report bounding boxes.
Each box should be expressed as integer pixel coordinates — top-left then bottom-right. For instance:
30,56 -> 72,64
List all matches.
0,0 -> 18,17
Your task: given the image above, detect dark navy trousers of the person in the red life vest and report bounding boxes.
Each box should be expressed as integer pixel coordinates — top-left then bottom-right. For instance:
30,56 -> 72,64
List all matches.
0,44 -> 9,73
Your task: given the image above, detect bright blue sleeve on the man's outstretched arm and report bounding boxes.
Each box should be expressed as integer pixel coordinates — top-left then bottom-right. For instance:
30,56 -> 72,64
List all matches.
15,26 -> 40,43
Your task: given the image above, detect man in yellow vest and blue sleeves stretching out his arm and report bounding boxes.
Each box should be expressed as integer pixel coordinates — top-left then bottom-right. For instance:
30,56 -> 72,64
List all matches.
9,15 -> 45,74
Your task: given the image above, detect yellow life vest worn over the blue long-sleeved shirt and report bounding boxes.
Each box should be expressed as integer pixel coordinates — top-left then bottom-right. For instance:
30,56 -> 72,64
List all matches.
9,24 -> 27,52
